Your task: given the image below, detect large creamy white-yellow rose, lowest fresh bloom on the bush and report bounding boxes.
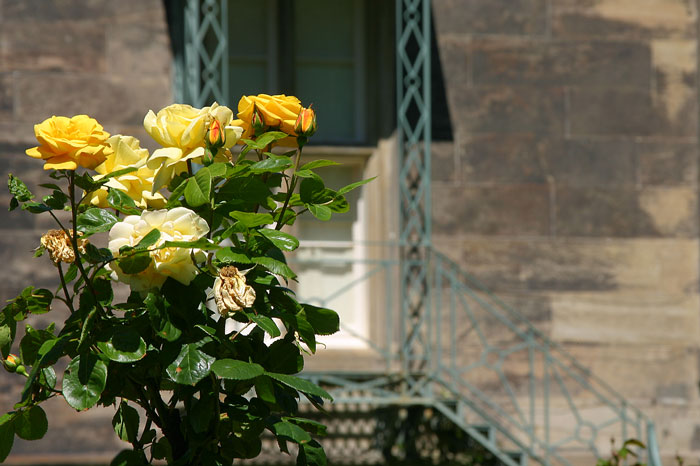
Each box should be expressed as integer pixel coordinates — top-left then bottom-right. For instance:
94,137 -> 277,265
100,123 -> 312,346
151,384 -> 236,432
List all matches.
108,207 -> 209,291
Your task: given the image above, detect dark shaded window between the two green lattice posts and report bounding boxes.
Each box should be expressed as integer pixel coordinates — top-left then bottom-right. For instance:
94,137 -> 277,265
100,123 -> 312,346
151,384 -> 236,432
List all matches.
228,0 -> 394,145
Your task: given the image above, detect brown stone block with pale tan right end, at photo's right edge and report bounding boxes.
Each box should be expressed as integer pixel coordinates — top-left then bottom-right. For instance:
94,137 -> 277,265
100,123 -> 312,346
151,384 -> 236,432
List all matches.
556,186 -> 697,237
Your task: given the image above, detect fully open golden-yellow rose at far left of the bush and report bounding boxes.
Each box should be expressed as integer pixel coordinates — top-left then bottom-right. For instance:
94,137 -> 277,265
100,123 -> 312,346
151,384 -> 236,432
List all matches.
26,115 -> 111,170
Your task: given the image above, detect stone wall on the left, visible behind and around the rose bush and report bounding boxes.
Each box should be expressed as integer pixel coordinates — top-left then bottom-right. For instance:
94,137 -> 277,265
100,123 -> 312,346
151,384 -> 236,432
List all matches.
0,0 -> 172,464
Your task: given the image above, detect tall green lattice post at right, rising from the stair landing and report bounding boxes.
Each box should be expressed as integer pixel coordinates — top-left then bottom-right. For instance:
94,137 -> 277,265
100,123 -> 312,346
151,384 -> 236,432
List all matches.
396,0 -> 432,385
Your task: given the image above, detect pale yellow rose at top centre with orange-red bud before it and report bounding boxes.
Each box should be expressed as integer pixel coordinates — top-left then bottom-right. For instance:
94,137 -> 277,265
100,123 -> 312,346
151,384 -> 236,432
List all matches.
143,102 -> 243,192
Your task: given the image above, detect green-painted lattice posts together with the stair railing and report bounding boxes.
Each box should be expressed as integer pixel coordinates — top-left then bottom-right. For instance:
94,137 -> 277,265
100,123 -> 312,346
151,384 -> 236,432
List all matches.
175,0 -> 661,466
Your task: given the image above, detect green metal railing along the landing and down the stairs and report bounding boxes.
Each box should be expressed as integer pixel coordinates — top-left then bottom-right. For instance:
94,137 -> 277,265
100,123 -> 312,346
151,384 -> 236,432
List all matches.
294,245 -> 660,466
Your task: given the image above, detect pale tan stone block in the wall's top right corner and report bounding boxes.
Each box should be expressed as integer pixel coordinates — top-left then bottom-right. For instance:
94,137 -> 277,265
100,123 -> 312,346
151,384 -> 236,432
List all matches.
551,0 -> 698,39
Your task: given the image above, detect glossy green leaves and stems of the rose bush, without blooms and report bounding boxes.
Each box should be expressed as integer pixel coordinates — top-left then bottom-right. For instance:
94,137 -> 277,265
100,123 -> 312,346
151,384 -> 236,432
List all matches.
0,114 -> 372,466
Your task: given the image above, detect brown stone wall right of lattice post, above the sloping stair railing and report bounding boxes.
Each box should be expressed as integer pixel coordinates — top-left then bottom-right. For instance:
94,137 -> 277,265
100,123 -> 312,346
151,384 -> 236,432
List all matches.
433,0 -> 700,459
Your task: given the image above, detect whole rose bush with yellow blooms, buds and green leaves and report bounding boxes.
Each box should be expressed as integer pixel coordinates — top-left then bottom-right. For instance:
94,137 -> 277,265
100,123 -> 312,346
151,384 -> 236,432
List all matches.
0,95 -> 372,465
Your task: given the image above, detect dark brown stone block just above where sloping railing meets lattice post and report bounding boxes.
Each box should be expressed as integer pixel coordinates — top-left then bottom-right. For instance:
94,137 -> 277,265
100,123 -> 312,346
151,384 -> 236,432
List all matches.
433,185 -> 550,236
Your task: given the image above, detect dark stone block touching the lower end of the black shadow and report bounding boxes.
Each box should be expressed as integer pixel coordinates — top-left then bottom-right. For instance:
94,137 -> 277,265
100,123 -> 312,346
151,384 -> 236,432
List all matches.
446,86 -> 565,135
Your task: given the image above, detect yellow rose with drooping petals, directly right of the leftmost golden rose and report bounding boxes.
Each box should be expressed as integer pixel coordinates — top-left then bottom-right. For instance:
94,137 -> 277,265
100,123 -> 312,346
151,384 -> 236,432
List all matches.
89,134 -> 166,209
